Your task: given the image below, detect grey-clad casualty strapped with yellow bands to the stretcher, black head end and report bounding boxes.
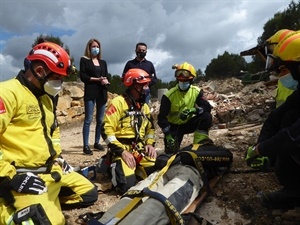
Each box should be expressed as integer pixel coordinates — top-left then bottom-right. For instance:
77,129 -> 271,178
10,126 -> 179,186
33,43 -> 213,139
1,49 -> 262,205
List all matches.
88,140 -> 233,225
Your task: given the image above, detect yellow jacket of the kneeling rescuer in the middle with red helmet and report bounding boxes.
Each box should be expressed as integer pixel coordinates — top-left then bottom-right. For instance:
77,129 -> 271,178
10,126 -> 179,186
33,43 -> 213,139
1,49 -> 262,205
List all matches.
102,93 -> 155,154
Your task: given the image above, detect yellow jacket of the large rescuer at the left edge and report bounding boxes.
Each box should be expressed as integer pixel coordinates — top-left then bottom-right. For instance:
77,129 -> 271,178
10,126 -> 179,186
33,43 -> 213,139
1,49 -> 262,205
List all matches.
0,75 -> 61,178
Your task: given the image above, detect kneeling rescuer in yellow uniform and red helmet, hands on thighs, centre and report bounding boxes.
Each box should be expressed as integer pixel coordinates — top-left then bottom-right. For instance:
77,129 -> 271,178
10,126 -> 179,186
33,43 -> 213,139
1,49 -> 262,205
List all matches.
102,69 -> 157,193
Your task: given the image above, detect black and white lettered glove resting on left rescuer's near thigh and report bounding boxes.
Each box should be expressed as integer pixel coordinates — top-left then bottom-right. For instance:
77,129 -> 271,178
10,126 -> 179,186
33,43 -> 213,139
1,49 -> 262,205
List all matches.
8,172 -> 47,195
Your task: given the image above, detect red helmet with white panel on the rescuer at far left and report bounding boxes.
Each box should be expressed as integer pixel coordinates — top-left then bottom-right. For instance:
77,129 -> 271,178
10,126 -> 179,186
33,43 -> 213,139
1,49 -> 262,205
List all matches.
27,42 -> 72,77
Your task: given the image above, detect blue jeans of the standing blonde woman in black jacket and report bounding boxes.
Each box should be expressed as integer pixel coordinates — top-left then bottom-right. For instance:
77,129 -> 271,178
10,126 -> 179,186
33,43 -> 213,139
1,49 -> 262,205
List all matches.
82,99 -> 106,146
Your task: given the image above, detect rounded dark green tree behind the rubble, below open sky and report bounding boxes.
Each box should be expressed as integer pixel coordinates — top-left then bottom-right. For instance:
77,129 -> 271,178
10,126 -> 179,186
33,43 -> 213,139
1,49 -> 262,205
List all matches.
205,51 -> 247,79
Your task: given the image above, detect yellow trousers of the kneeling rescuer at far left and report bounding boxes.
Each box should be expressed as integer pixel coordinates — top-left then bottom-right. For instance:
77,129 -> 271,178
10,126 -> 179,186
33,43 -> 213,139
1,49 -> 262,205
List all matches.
0,165 -> 98,225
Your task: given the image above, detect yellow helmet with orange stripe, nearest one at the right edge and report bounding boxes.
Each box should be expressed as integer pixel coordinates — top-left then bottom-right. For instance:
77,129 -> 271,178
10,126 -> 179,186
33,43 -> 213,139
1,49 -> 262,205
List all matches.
273,31 -> 300,62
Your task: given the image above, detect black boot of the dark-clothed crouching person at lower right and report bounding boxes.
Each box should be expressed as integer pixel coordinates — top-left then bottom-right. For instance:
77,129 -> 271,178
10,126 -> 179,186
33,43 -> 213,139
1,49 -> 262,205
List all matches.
261,188 -> 300,209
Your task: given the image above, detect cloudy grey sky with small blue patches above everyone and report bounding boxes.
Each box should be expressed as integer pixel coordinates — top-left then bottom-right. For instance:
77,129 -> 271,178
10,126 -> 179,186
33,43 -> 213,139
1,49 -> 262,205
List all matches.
0,0 -> 290,82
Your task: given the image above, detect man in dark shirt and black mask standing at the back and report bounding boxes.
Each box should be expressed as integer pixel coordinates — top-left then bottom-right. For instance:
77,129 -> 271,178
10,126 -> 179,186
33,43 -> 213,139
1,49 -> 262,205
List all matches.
122,42 -> 157,104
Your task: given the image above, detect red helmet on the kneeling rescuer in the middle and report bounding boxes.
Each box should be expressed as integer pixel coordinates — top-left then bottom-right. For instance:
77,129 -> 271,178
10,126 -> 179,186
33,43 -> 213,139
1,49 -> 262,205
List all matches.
124,69 -> 151,87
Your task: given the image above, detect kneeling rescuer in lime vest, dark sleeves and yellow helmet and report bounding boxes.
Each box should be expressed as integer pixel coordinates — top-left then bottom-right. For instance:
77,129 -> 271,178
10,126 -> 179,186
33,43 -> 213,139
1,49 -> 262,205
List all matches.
157,62 -> 212,153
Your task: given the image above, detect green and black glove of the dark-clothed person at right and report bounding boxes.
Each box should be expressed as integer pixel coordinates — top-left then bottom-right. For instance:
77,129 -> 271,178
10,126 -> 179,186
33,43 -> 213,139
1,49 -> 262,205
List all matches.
245,146 -> 270,172
